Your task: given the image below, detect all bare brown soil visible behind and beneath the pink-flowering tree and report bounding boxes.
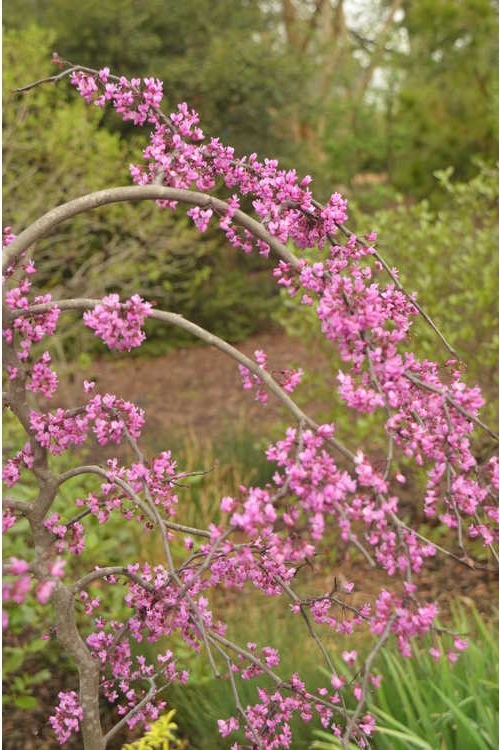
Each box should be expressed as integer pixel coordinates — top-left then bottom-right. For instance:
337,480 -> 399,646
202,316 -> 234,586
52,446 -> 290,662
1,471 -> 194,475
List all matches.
3,332 -> 497,750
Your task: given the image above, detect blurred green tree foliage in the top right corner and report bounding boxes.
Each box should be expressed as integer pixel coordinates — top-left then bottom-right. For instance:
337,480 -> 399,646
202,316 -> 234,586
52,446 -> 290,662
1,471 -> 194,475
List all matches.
389,0 -> 498,197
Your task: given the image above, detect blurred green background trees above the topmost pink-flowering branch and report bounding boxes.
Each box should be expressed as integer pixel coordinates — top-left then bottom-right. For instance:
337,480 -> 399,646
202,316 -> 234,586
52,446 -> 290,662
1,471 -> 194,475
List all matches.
4,0 -> 498,207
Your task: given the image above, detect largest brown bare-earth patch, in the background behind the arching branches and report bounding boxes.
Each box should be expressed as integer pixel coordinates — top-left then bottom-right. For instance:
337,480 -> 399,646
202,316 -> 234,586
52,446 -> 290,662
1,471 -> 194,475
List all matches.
58,333 -> 333,439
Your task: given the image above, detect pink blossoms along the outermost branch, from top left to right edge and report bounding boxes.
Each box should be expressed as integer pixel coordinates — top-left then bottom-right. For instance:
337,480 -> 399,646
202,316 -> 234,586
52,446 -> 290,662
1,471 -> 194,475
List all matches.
66,74 -> 498,544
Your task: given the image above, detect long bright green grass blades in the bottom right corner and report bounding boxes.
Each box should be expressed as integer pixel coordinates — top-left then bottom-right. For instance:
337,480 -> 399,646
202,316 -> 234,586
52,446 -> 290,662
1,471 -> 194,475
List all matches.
312,605 -> 498,750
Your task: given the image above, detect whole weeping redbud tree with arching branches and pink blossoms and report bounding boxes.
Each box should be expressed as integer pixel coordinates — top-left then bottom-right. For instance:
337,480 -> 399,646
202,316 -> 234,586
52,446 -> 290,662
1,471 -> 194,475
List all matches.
3,54 -> 498,750
